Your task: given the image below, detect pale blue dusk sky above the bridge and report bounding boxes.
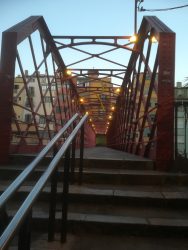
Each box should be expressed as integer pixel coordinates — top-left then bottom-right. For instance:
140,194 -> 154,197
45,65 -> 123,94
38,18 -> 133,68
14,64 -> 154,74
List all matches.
0,0 -> 188,82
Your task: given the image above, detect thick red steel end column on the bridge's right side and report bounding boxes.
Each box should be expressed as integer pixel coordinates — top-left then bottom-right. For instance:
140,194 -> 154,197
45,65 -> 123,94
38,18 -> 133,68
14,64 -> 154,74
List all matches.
156,33 -> 175,171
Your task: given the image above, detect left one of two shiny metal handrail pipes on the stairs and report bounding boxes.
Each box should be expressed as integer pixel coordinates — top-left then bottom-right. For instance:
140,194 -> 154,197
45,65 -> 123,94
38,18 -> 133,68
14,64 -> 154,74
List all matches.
0,114 -> 78,209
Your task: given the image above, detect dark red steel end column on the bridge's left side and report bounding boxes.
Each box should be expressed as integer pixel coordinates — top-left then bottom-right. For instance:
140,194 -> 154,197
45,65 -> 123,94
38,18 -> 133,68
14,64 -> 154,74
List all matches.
0,32 -> 17,163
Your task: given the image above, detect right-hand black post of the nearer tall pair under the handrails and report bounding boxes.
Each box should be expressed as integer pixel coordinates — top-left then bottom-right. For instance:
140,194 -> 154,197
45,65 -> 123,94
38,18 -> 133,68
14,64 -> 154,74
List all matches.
61,147 -> 70,242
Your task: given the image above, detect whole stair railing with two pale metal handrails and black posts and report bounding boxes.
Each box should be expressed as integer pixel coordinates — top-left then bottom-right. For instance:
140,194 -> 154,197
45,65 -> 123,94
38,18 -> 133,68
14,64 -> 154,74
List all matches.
0,114 -> 88,250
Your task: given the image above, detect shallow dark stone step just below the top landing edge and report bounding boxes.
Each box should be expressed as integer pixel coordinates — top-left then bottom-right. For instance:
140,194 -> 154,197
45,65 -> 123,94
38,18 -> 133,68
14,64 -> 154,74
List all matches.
0,165 -> 188,185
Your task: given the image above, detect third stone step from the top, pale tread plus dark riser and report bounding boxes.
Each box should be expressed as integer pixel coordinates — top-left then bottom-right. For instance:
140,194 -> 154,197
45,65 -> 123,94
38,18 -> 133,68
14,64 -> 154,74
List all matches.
0,181 -> 188,208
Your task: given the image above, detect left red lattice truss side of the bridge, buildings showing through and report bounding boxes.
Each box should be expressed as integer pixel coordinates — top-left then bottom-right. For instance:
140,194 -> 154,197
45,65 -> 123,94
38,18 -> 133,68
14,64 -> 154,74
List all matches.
0,16 -> 80,162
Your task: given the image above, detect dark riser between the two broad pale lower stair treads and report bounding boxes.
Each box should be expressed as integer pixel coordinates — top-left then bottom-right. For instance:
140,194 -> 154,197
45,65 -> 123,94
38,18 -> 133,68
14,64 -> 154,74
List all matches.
7,198 -> 188,219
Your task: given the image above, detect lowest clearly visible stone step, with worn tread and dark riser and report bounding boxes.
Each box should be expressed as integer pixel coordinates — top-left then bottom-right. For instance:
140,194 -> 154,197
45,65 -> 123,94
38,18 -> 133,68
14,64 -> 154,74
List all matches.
6,209 -> 188,237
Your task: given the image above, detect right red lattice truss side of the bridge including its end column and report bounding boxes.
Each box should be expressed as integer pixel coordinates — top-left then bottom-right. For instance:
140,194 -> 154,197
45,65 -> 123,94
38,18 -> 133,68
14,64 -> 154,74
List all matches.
107,16 -> 175,170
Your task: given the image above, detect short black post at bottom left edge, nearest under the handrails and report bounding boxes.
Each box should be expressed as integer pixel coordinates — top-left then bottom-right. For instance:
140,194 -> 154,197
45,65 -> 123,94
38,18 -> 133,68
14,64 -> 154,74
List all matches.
18,210 -> 32,250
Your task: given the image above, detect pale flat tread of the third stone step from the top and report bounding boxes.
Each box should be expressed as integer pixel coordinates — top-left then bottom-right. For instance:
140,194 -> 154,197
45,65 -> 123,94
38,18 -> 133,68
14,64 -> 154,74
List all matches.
0,181 -> 188,200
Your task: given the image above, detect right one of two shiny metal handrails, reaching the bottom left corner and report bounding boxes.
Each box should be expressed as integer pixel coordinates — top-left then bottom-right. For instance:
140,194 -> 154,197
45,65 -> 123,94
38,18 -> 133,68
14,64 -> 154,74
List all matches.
0,114 -> 88,250
